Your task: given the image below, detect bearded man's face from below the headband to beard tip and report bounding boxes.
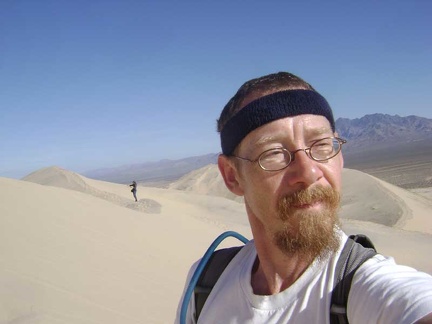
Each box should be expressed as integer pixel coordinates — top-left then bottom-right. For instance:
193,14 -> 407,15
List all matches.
236,115 -> 343,258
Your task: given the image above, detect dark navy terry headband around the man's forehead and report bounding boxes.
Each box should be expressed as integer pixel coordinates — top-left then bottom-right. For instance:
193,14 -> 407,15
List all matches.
220,90 -> 335,155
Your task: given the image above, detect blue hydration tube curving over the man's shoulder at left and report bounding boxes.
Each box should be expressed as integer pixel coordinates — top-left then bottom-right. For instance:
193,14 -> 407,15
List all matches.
180,231 -> 249,324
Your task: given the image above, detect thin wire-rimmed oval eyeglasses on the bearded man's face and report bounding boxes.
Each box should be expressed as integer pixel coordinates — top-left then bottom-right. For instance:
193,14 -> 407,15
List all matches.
232,137 -> 347,171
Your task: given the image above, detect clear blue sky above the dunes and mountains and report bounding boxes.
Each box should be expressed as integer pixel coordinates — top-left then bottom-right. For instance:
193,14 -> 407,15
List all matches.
0,0 -> 432,178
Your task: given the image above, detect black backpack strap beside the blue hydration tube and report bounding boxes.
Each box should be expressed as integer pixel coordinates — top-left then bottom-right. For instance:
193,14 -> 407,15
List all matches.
194,246 -> 243,321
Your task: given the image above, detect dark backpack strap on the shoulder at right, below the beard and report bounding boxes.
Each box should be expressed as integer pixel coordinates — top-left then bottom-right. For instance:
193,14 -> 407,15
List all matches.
330,234 -> 376,324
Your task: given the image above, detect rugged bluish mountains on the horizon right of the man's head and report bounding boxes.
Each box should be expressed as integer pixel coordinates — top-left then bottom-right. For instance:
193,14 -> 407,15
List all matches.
336,114 -> 432,150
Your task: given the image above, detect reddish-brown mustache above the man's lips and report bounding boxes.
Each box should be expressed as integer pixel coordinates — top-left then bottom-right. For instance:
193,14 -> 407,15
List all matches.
280,186 -> 340,210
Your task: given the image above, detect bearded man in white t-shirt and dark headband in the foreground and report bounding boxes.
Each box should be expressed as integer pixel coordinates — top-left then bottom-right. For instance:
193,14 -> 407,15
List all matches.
177,72 -> 432,323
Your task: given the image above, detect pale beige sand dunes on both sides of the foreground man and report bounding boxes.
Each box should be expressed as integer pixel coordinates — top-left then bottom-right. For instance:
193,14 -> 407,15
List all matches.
0,165 -> 432,324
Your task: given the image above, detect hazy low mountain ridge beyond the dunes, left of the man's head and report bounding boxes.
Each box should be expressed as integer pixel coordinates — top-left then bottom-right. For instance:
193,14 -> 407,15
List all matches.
83,153 -> 219,187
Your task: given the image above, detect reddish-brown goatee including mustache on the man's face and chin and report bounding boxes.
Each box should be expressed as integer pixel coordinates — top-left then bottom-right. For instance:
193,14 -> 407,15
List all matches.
273,186 -> 340,261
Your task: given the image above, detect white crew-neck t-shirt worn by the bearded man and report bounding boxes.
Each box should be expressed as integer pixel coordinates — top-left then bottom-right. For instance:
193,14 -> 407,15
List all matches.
176,234 -> 432,324
